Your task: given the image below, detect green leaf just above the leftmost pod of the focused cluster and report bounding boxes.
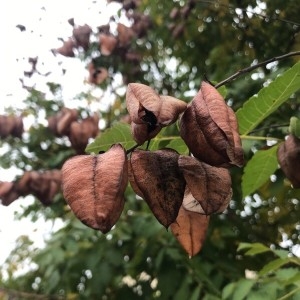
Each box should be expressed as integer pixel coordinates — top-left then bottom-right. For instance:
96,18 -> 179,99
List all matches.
85,122 -> 136,153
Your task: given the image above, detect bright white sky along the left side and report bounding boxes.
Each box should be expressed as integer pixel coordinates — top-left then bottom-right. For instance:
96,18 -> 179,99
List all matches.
0,0 -> 119,271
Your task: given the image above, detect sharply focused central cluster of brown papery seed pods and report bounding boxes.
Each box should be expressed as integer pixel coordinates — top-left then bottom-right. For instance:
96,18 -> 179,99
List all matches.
62,82 -> 244,256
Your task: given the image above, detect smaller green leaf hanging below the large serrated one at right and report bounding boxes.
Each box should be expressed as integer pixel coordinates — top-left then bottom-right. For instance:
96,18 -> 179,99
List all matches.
242,145 -> 278,197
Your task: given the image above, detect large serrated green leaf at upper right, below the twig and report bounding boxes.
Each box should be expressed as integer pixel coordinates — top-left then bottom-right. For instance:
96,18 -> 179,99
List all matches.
236,62 -> 300,135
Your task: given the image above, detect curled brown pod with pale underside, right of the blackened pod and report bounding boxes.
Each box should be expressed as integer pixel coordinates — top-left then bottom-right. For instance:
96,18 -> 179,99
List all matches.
178,155 -> 232,215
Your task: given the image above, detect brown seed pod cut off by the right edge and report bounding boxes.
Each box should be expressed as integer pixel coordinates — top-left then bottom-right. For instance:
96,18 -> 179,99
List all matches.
277,134 -> 300,188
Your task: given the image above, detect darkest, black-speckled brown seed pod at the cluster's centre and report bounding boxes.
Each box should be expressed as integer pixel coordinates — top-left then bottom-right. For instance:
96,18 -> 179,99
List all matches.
129,149 -> 185,228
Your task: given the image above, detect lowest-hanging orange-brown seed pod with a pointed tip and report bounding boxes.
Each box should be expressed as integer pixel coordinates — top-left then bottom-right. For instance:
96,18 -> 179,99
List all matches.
170,206 -> 209,257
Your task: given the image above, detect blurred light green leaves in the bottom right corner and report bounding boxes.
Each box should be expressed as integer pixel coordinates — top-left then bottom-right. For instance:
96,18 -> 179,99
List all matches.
222,243 -> 300,300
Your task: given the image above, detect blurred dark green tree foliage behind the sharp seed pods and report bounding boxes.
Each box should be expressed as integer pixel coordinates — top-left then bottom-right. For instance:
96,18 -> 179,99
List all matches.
0,0 -> 300,300
